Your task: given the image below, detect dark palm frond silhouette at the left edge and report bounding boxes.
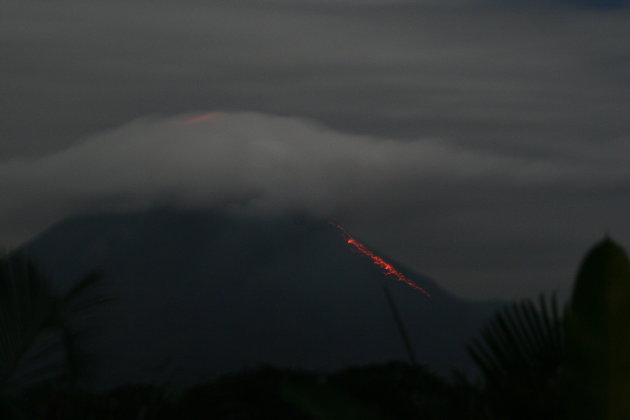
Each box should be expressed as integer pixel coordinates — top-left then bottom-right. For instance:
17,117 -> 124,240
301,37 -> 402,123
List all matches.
0,256 -> 105,416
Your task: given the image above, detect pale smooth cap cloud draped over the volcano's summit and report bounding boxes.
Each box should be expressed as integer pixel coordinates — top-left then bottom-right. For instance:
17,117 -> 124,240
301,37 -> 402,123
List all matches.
0,113 -> 630,298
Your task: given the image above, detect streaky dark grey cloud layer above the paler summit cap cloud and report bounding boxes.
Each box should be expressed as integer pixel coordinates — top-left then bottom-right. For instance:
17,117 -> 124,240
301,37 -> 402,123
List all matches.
1,1 -> 630,156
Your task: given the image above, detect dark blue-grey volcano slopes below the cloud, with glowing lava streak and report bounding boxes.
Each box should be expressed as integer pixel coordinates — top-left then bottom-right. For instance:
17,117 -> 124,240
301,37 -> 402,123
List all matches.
19,209 -> 504,385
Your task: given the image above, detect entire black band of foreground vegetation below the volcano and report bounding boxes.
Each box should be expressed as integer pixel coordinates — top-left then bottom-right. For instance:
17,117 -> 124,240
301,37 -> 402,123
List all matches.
0,239 -> 630,420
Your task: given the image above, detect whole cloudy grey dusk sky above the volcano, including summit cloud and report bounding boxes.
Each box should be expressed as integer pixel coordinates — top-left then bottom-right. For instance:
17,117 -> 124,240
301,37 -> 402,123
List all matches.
0,0 -> 630,297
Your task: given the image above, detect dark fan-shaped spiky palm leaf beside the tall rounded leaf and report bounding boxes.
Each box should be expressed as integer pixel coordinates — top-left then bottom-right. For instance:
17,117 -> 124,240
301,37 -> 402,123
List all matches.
468,296 -> 563,419
